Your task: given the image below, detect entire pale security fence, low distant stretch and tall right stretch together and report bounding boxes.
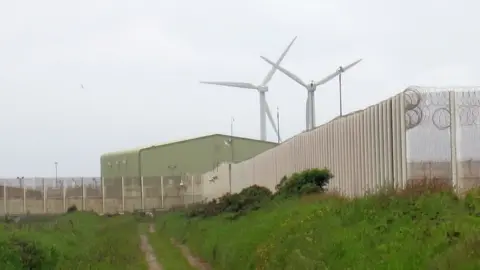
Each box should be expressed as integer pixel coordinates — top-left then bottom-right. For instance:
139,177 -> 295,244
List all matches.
4,87 -> 480,214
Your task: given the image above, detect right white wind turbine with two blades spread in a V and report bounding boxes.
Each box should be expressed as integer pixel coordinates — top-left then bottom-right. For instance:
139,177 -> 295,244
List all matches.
260,56 -> 362,130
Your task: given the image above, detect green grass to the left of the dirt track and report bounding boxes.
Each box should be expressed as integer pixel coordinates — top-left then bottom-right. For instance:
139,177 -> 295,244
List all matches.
0,212 -> 147,270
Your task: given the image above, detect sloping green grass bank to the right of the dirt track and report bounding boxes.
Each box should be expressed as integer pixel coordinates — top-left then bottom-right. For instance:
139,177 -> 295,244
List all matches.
157,187 -> 480,270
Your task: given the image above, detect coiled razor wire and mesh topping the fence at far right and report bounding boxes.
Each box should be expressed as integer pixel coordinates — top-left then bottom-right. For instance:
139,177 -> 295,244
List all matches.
404,87 -> 480,130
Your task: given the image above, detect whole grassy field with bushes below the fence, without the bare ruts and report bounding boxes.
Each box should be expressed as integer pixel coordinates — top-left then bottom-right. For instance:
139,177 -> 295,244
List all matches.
0,170 -> 480,270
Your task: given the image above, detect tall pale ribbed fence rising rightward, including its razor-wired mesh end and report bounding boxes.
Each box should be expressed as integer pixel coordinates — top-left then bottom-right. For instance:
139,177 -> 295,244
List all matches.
202,87 -> 480,199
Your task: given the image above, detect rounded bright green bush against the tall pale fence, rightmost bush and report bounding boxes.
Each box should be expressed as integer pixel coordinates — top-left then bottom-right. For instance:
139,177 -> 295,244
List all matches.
275,168 -> 333,197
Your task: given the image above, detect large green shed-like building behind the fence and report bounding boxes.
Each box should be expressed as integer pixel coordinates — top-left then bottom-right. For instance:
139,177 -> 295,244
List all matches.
100,134 -> 277,179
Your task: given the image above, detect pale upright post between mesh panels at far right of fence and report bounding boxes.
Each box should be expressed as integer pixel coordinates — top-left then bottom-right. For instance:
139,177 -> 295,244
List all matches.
449,91 -> 460,193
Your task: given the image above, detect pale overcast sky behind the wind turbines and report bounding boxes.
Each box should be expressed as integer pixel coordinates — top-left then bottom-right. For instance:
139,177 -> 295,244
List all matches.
0,0 -> 480,176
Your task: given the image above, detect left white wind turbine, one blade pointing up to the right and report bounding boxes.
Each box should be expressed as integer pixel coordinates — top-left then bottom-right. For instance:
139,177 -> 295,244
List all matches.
200,37 -> 297,141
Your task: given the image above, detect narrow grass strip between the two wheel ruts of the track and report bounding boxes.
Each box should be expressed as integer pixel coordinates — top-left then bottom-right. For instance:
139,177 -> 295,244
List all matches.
142,221 -> 195,270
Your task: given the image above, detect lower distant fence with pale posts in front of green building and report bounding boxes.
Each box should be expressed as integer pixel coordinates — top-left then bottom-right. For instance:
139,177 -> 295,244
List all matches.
0,175 -> 203,215
